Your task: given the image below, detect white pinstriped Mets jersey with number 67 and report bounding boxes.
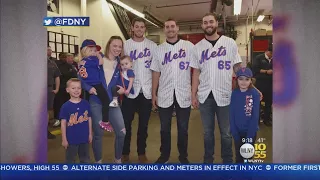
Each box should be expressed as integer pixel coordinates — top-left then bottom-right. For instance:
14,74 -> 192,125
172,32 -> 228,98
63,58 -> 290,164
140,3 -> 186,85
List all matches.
150,39 -> 194,108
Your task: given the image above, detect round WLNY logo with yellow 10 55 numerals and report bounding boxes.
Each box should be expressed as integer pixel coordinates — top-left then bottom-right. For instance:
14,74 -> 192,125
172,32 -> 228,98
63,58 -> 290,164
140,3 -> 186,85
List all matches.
240,143 -> 267,159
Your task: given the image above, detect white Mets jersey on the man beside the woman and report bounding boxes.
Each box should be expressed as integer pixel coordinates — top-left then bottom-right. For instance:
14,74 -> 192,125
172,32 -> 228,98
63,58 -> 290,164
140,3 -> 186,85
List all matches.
124,38 -> 157,99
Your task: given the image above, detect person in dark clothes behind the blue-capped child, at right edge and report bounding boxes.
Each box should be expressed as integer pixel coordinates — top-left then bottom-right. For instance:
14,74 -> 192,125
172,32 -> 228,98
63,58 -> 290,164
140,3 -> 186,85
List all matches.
252,47 -> 273,126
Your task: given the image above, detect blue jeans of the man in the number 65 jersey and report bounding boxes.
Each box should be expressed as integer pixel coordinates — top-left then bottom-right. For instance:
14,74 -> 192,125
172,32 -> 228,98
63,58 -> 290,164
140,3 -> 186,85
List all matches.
200,94 -> 233,163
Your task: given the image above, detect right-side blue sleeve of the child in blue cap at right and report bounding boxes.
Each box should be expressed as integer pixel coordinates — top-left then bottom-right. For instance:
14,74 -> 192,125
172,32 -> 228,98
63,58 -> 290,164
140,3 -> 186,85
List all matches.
247,89 -> 260,138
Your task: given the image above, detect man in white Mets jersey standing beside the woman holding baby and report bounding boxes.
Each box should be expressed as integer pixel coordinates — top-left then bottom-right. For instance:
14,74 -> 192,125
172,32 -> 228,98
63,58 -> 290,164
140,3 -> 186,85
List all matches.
122,18 -> 157,163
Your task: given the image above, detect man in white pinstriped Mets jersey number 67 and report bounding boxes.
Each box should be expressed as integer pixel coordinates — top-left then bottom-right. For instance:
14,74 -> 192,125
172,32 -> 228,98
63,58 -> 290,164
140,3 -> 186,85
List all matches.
151,19 -> 194,164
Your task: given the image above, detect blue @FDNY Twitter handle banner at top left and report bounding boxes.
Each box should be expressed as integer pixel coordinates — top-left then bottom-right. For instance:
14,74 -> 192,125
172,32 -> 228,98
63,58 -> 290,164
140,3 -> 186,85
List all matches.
43,17 -> 90,27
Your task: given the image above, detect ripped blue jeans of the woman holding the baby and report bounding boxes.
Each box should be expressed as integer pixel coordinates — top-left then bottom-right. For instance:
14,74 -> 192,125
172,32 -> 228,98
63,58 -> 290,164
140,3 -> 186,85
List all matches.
90,100 -> 126,161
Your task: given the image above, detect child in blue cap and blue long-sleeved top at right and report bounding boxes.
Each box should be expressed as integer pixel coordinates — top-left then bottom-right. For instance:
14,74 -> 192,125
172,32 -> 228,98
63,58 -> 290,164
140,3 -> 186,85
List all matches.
230,68 -> 260,163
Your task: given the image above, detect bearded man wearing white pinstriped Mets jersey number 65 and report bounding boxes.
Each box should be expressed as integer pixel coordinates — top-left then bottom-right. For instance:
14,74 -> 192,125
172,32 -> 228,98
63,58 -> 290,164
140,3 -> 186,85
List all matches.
190,13 -> 242,163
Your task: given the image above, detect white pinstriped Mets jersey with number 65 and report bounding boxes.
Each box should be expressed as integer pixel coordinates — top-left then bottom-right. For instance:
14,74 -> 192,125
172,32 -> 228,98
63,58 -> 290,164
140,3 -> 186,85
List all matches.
190,36 -> 242,106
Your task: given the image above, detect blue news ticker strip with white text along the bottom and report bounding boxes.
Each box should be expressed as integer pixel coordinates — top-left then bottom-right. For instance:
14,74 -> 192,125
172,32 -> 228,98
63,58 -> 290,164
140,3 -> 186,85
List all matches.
0,164 -> 320,172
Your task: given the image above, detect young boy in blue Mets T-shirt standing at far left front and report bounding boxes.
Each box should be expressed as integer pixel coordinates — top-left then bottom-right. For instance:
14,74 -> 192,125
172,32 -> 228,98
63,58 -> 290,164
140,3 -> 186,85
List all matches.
60,78 -> 92,163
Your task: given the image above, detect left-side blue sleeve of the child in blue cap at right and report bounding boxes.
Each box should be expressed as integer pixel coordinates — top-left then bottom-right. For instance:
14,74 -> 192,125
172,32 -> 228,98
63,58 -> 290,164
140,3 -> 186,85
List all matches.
229,90 -> 241,142
